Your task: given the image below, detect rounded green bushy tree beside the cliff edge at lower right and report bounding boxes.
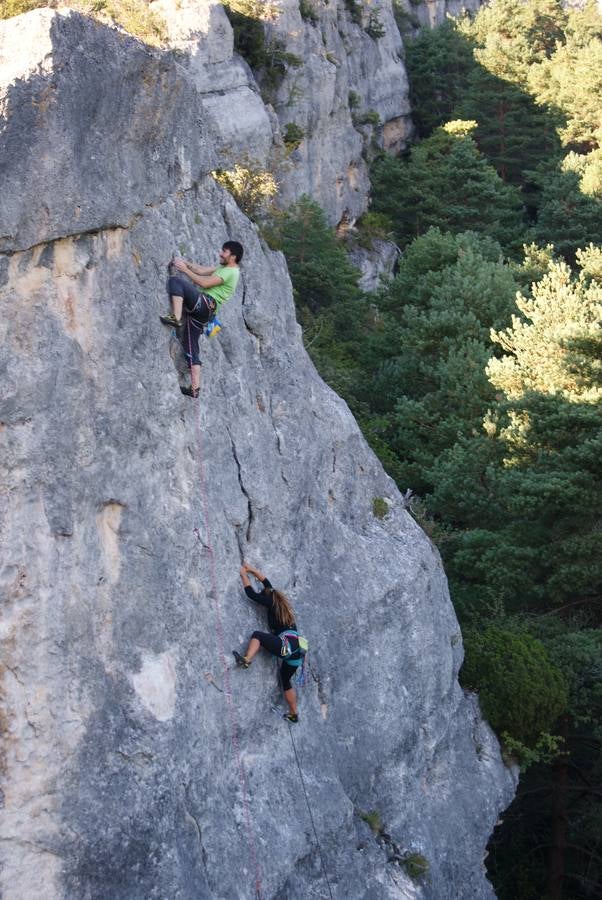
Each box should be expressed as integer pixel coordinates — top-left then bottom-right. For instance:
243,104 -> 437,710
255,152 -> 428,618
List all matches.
460,625 -> 568,750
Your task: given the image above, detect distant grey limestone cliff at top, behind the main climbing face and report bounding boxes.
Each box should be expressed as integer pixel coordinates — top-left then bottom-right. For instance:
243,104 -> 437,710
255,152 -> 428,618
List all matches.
139,0 -> 480,225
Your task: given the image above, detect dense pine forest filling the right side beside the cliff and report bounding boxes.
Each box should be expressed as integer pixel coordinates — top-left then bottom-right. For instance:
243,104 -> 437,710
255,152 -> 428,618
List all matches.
271,0 -> 602,900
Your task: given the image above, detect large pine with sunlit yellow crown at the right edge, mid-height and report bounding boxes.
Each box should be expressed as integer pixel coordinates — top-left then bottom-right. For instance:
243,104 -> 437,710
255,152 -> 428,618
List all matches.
431,247 -> 602,611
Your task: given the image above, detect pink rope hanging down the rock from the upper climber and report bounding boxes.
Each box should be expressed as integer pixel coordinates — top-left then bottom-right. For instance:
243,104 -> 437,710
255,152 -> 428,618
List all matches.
186,316 -> 261,900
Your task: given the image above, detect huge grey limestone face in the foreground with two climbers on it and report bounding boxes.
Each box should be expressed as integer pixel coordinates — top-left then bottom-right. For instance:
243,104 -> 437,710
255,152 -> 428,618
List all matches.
0,10 -> 514,900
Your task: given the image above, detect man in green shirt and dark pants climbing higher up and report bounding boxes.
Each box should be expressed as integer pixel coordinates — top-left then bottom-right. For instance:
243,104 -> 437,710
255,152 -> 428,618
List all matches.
160,241 -> 244,398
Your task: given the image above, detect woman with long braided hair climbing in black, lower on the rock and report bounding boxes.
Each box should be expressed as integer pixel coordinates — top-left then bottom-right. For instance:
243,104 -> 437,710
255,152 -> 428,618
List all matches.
232,563 -> 307,722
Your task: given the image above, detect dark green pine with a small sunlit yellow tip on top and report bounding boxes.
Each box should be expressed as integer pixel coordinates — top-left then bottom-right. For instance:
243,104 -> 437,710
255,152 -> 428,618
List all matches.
372,122 -> 526,252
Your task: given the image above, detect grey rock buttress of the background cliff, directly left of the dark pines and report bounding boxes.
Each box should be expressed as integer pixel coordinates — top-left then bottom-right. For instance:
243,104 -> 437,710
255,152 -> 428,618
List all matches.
262,0 -> 412,223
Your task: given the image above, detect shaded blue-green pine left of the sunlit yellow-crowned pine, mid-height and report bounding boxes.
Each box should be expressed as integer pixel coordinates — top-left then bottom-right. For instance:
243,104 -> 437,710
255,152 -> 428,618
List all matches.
360,229 -> 517,492
